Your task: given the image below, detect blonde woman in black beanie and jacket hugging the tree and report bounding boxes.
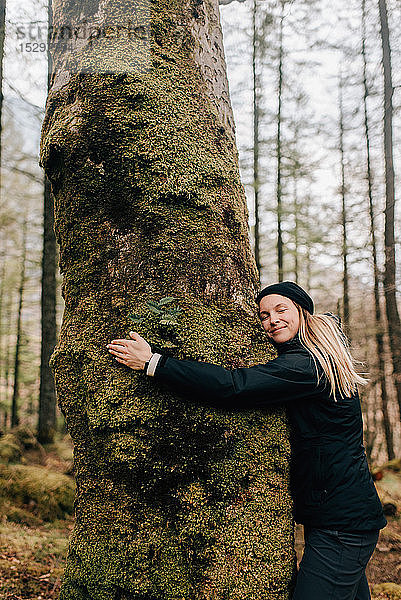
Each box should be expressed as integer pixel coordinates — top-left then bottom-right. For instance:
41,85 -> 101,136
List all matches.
108,281 -> 387,600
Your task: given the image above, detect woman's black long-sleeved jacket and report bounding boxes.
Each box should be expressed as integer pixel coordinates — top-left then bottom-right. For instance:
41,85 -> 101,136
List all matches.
155,335 -> 387,531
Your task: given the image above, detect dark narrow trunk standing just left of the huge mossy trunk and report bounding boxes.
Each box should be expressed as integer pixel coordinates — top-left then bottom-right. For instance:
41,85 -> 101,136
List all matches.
38,2 -> 57,444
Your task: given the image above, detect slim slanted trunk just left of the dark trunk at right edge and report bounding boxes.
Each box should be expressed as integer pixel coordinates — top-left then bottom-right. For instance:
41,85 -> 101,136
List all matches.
362,0 -> 395,460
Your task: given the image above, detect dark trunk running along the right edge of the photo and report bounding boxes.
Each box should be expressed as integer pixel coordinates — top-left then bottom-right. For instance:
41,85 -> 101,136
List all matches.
379,0 -> 401,415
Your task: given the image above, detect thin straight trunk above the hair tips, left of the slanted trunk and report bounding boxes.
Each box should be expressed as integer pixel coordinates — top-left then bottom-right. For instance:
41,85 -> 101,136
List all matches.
339,73 -> 350,337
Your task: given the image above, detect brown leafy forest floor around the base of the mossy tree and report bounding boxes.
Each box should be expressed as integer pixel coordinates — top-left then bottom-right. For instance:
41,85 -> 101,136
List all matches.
0,428 -> 401,600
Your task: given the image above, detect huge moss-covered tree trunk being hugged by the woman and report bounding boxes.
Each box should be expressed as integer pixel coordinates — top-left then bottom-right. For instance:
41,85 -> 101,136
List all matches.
41,0 -> 294,600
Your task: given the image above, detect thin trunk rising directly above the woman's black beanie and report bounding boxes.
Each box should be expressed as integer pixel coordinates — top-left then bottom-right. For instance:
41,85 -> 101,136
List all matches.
252,0 -> 261,281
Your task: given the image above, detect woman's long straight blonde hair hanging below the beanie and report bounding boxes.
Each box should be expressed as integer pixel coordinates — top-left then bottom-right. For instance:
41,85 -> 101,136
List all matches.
294,302 -> 368,401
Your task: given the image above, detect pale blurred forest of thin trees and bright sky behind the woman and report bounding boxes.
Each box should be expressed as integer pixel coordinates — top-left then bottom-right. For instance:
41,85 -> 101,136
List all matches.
0,0 -> 401,596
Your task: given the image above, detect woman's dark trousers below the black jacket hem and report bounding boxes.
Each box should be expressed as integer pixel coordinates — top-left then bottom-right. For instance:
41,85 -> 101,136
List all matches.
292,528 -> 379,600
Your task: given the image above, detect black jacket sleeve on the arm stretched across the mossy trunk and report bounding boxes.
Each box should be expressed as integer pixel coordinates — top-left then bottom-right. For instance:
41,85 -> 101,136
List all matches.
154,354 -> 321,409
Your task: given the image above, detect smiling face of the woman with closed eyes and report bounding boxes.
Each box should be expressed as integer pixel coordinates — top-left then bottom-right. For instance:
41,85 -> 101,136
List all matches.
259,294 -> 299,344
